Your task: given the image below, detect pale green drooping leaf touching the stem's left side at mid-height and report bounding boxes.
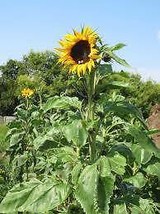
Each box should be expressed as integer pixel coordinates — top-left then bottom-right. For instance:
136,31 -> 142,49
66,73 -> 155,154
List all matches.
62,120 -> 88,147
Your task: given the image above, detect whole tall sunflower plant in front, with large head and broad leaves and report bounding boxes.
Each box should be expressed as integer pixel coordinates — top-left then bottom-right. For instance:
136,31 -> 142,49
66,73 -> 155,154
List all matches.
0,27 -> 160,214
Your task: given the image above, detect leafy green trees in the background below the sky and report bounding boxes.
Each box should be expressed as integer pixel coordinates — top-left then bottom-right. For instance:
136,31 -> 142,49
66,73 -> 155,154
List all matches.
0,51 -> 160,118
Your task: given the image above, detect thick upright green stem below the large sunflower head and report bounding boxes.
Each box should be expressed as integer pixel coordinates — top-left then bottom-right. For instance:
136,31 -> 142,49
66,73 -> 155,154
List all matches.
87,71 -> 96,163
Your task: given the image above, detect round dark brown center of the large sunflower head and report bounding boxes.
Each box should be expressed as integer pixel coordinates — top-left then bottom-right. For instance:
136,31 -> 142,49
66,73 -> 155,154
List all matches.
70,40 -> 91,64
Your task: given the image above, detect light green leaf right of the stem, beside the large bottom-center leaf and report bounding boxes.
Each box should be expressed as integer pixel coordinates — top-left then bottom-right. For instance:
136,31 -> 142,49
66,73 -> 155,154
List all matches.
108,154 -> 126,175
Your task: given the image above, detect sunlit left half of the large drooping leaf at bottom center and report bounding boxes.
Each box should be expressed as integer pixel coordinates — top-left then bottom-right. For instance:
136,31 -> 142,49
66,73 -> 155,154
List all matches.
75,164 -> 98,214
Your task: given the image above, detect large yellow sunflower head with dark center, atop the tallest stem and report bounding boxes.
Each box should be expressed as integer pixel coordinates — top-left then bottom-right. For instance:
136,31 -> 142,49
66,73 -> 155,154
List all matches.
57,27 -> 100,76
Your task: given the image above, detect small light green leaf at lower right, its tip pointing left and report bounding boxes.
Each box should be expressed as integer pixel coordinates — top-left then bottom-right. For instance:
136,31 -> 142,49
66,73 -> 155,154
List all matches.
124,172 -> 147,188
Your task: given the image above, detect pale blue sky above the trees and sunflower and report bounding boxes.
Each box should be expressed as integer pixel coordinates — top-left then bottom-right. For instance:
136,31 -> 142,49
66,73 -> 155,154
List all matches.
0,0 -> 160,82
